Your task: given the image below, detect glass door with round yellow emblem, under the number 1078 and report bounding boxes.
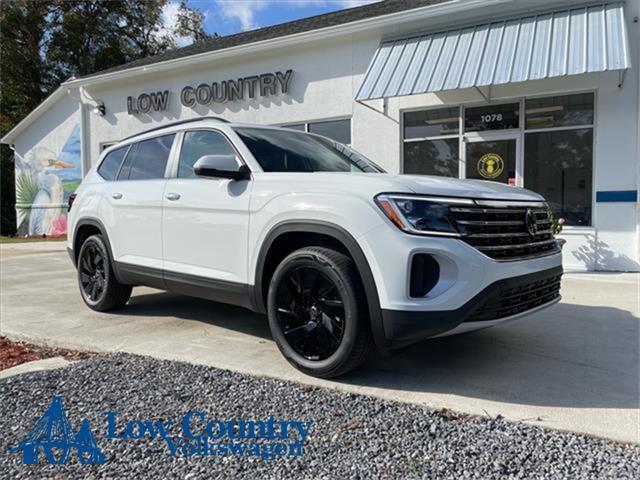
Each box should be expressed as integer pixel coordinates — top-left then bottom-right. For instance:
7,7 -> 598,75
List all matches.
464,134 -> 522,185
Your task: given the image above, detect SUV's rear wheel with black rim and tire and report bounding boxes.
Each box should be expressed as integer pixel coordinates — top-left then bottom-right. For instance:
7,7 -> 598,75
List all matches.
77,235 -> 132,312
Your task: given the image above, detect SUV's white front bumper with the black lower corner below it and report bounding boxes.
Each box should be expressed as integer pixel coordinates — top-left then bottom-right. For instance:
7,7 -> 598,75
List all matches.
358,224 -> 562,350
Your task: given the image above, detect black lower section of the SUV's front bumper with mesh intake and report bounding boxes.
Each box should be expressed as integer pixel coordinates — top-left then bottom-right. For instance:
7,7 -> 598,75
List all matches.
382,266 -> 562,348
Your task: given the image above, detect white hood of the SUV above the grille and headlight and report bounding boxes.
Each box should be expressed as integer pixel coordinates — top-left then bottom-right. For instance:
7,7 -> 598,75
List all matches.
384,175 -> 544,200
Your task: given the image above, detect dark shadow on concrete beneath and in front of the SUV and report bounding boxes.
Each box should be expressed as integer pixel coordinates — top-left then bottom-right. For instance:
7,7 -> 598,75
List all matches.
118,292 -> 640,408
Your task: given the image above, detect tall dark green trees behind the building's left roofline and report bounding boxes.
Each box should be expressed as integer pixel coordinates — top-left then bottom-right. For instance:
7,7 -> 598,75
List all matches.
0,0 -> 207,234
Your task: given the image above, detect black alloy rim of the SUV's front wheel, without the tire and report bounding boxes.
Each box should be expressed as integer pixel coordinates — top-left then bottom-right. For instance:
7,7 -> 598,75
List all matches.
276,267 -> 345,360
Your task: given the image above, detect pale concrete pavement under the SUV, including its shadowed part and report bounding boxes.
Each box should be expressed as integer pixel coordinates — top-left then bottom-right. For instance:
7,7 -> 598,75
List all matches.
0,242 -> 640,443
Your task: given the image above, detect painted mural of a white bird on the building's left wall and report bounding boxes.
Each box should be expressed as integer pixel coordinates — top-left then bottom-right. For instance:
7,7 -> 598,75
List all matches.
15,124 -> 82,236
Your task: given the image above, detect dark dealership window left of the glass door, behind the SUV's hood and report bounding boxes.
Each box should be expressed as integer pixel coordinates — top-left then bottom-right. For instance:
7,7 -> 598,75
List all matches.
403,107 -> 460,177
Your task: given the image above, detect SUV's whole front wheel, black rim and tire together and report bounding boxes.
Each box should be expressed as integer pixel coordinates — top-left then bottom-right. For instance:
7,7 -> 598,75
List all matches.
267,247 -> 373,378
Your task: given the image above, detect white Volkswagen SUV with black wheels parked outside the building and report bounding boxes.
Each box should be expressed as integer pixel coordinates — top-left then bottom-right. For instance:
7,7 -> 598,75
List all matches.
68,118 -> 562,377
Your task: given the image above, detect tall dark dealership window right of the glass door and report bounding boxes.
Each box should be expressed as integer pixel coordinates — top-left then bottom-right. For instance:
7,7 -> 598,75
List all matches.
524,93 -> 594,226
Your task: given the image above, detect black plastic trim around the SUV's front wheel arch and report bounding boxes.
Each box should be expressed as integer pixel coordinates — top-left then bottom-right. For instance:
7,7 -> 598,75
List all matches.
252,220 -> 388,350
